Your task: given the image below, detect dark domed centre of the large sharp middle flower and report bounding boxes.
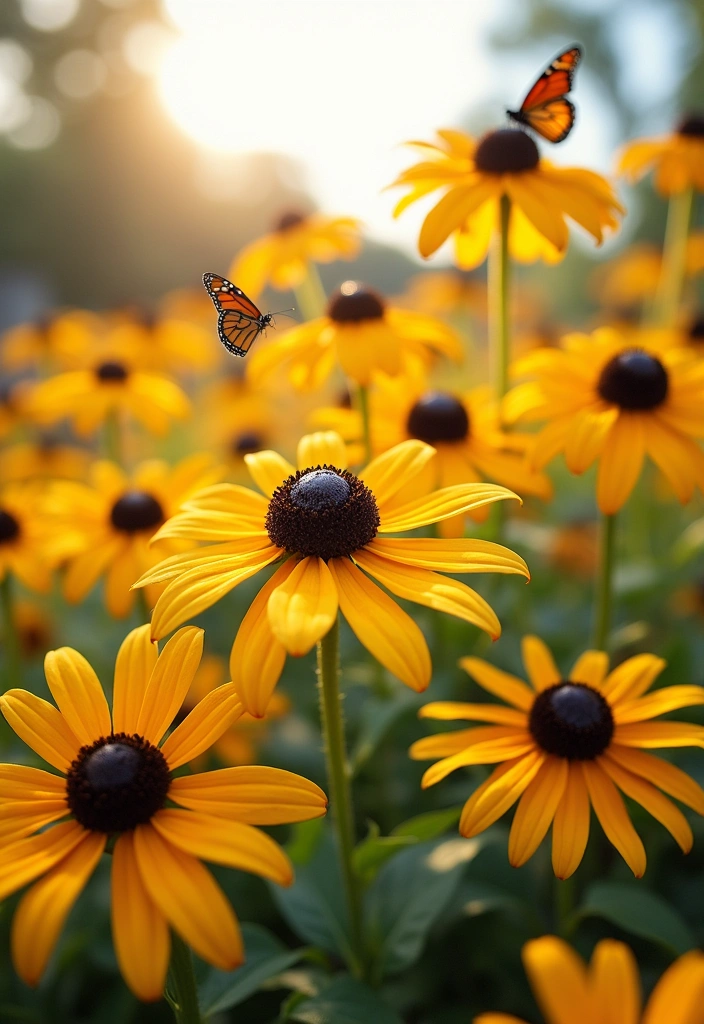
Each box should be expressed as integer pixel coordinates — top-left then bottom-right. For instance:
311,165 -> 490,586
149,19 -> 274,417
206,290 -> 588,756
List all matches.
266,466 -> 381,561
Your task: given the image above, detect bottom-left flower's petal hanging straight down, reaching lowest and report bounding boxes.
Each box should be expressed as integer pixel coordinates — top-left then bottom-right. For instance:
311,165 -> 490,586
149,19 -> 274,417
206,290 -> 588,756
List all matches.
111,831 -> 171,1002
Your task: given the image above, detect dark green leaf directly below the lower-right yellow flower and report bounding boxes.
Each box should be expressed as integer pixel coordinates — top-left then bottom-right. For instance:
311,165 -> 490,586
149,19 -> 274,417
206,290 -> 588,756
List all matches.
577,882 -> 697,955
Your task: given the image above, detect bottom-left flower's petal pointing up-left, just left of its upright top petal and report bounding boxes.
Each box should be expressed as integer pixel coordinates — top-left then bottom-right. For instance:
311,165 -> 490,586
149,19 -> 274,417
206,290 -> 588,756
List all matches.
44,647 -> 113,745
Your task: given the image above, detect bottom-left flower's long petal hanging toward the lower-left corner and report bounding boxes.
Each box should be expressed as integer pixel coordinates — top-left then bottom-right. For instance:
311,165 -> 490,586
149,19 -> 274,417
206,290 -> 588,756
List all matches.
10,833 -> 107,986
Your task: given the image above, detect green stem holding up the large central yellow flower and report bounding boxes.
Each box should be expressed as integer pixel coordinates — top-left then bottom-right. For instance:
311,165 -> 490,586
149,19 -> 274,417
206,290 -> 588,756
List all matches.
317,621 -> 363,977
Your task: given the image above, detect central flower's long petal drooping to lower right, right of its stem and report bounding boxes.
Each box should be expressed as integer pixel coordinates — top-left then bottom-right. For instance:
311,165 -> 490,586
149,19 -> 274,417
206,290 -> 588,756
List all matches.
329,558 -> 431,692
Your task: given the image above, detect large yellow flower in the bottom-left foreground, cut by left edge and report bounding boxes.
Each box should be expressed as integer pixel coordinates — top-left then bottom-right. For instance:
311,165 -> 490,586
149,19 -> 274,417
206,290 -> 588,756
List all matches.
0,626 -> 325,999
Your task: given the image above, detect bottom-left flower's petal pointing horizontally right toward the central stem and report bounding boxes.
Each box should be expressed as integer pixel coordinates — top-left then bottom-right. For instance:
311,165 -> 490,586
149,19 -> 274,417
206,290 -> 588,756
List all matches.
169,765 -> 327,825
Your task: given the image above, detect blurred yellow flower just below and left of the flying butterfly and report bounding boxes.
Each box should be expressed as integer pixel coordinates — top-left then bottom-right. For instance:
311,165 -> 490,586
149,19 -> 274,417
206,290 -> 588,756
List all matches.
28,358 -> 190,437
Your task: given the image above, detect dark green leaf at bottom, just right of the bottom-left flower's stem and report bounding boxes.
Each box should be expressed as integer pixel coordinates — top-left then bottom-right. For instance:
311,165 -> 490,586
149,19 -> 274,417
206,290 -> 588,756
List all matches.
200,925 -> 306,1017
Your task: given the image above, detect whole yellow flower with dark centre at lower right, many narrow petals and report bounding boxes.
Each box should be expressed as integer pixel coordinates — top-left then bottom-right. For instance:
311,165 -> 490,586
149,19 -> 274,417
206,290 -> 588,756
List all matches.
411,636 -> 704,879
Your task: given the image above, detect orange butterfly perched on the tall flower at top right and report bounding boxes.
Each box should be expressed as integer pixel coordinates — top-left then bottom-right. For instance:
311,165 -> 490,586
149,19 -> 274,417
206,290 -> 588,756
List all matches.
507,46 -> 582,142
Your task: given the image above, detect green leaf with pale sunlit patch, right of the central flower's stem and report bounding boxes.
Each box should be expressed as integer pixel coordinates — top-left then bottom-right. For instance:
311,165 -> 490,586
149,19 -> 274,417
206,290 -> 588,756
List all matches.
366,837 -> 486,978
